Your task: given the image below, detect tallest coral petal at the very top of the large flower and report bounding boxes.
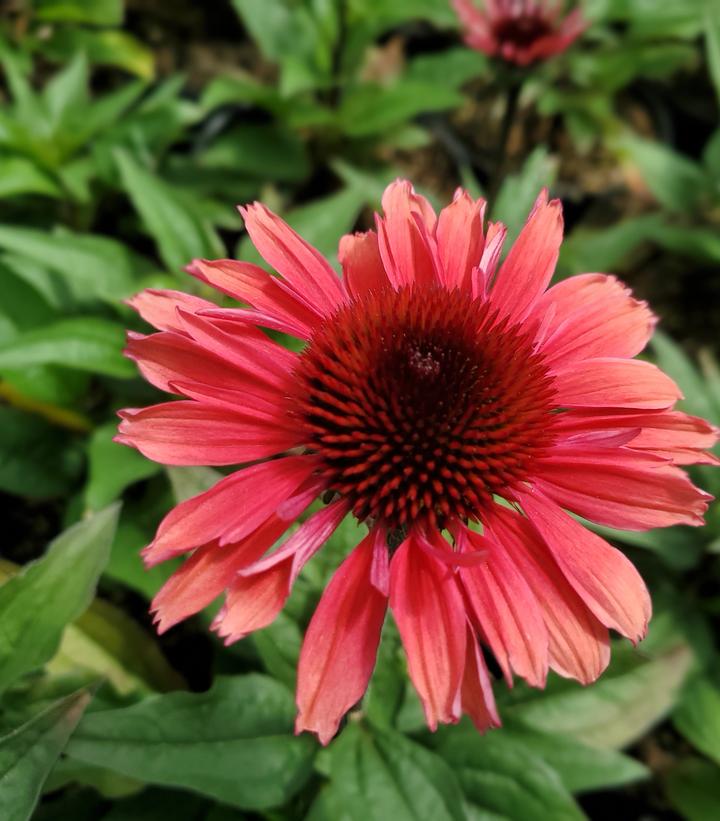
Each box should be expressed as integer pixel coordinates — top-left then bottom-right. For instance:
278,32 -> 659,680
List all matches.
377,180 -> 439,288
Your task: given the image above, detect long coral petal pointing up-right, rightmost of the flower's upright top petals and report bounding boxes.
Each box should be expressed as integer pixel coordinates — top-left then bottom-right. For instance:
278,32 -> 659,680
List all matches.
490,191 -> 563,322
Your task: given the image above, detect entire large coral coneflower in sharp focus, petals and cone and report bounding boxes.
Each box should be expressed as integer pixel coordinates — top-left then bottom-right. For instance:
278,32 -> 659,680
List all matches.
118,181 -> 716,743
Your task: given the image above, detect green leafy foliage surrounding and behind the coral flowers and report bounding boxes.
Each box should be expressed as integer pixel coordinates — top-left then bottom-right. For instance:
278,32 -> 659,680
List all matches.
0,0 -> 720,821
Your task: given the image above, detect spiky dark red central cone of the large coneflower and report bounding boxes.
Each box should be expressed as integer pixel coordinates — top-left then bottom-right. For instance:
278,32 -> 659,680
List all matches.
295,288 -> 554,530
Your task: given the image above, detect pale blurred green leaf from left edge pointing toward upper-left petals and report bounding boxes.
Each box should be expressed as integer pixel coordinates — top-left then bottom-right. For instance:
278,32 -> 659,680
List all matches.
0,225 -> 138,301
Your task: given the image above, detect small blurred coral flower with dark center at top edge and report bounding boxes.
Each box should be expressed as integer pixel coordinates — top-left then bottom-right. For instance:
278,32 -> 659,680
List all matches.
453,0 -> 587,66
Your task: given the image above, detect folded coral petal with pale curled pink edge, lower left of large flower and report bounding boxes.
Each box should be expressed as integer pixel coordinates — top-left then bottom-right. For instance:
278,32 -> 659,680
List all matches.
213,500 -> 348,644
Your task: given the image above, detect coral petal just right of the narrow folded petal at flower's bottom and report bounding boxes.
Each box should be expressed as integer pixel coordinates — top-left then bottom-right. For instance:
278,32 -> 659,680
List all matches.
458,528 -> 548,687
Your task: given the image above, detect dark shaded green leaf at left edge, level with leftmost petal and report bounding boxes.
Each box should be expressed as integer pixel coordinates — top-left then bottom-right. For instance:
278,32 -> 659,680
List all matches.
0,406 -> 82,499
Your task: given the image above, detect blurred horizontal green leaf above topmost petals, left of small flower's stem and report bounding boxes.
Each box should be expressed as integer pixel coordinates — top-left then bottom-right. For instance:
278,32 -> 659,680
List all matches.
339,80 -> 464,137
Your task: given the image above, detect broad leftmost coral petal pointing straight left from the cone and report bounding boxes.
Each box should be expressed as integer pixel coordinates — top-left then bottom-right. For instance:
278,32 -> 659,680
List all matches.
116,401 -> 301,465
